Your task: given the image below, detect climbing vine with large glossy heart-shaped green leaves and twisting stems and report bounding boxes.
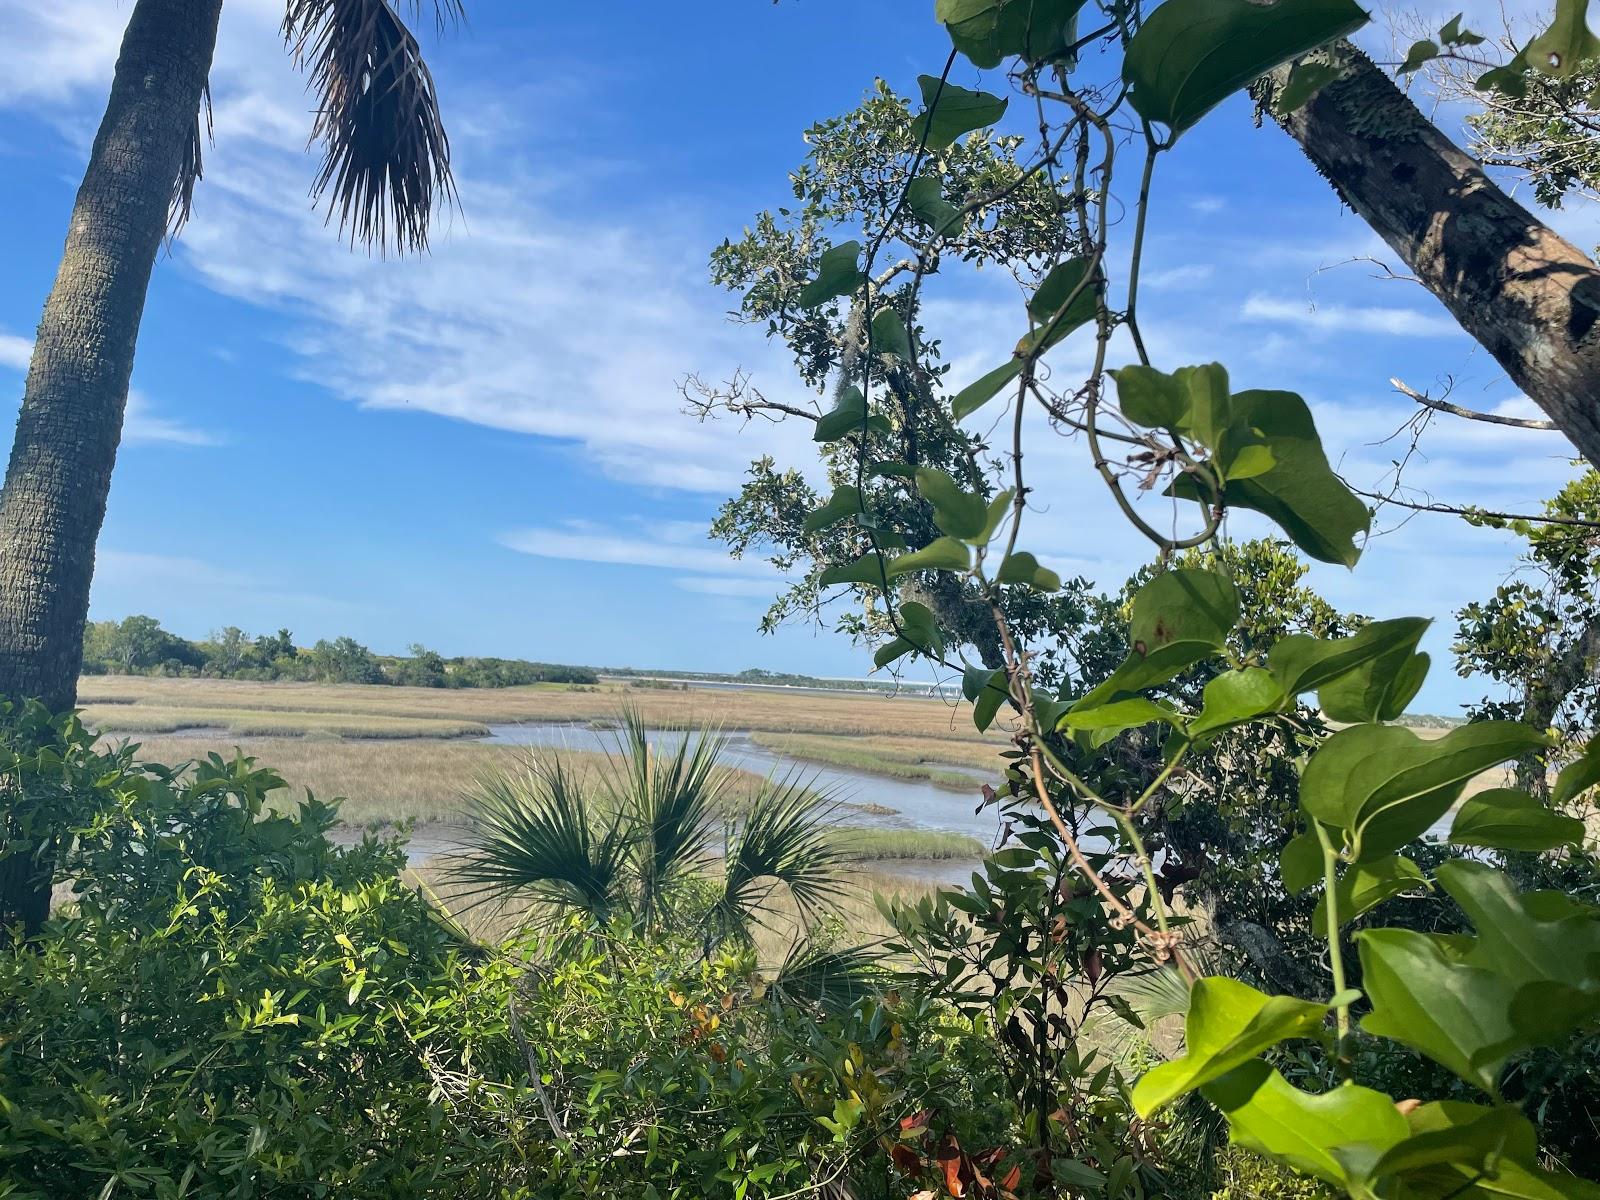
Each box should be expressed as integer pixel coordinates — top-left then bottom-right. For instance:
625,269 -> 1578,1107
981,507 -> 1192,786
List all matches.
768,0 -> 1600,1200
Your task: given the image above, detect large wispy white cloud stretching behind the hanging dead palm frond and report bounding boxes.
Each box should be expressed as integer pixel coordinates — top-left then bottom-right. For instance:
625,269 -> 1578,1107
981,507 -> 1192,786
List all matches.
0,0 -> 806,493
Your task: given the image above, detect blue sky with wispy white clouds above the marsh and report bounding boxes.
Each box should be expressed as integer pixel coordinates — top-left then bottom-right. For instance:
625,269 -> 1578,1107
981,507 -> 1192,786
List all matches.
0,0 -> 1597,710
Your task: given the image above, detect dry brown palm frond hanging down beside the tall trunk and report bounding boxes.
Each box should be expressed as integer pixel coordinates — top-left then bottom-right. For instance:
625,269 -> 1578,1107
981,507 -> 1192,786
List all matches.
283,0 -> 461,251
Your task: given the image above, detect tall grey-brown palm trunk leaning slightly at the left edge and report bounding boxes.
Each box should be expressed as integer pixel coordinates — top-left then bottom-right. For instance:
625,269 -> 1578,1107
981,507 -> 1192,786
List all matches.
0,0 -> 222,931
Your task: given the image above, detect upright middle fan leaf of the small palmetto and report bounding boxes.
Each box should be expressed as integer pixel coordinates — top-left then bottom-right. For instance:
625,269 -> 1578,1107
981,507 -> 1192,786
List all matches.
605,707 -> 728,928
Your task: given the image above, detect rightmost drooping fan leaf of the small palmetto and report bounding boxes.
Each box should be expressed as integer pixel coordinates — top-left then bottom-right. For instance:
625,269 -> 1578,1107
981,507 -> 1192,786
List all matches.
709,774 -> 843,939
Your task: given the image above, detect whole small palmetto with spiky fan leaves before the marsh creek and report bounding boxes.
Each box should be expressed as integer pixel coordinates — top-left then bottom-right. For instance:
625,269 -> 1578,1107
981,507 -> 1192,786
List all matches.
451,710 -> 842,950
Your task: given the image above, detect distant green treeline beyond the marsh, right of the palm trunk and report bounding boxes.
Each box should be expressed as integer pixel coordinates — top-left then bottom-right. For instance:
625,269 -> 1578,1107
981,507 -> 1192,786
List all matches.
83,616 -> 600,688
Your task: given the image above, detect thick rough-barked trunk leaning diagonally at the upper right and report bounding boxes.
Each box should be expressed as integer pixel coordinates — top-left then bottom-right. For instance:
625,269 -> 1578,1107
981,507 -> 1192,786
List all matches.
1256,42 -> 1600,467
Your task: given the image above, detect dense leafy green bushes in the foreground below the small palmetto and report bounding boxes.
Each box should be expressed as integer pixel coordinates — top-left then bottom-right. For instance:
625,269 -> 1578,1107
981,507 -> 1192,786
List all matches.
0,714 -> 1164,1200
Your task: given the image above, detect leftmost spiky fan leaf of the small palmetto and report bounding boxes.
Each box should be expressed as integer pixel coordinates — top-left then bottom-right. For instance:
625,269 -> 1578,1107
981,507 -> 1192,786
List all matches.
450,757 -> 629,925
